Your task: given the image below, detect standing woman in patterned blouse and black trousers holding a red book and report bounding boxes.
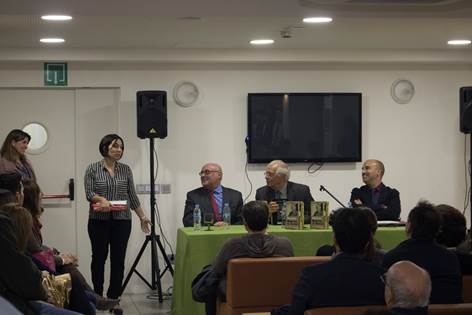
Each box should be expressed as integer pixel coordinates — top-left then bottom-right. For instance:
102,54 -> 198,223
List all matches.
84,134 -> 151,299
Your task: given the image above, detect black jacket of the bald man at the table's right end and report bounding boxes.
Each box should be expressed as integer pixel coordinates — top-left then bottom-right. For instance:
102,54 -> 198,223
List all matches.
351,183 -> 401,221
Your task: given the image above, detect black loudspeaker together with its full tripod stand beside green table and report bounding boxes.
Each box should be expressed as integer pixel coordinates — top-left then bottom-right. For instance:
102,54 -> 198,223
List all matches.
121,91 -> 174,302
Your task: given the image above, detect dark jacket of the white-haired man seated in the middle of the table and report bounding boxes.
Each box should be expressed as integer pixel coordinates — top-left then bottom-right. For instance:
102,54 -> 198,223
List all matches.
256,181 -> 313,224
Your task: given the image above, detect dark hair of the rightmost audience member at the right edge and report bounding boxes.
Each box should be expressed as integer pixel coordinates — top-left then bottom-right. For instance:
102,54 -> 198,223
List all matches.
436,205 -> 467,247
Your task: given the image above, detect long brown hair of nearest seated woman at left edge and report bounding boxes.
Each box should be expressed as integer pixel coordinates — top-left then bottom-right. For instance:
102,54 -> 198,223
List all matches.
2,203 -> 33,252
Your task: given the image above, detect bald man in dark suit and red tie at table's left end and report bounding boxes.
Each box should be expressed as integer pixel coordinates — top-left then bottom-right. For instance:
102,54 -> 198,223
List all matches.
182,163 -> 243,226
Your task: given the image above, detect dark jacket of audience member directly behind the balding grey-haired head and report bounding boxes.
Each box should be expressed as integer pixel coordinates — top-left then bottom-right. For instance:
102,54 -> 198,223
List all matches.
383,239 -> 462,304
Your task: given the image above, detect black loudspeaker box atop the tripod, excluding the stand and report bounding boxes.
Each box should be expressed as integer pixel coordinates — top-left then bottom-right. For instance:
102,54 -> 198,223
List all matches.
136,91 -> 167,139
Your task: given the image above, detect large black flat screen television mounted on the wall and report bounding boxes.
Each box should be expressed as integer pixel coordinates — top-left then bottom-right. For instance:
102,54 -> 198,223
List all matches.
246,93 -> 362,163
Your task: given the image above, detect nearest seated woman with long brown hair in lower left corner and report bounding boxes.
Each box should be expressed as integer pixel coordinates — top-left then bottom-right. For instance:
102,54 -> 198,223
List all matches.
0,204 -> 78,315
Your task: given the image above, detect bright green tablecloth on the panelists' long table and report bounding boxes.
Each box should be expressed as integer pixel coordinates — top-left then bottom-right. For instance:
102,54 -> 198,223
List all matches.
172,225 -> 406,315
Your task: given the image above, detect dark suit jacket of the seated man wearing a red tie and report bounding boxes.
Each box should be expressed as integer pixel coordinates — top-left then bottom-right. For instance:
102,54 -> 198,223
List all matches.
182,186 -> 243,226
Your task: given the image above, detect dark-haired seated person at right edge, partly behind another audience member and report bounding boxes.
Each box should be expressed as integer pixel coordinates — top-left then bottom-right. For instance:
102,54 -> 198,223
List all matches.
436,205 -> 472,275
